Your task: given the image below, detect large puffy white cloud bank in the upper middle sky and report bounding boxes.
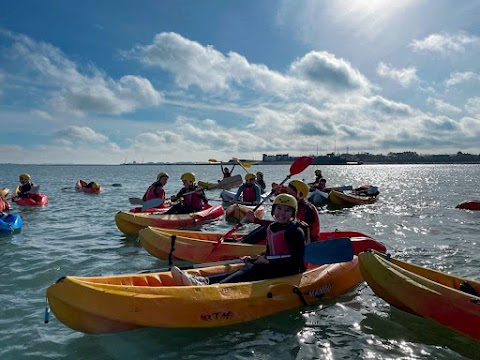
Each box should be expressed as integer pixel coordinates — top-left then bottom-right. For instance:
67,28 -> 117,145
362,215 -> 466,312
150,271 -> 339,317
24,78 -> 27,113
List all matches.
123,33 -> 371,99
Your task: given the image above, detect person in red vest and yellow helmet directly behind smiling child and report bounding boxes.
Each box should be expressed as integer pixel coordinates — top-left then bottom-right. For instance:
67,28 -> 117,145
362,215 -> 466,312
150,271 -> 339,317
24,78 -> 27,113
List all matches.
244,180 -> 320,244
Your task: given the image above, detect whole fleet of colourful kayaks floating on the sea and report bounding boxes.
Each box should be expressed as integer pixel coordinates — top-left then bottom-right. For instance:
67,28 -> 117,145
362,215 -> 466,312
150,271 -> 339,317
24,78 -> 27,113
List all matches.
4,160 -> 468,341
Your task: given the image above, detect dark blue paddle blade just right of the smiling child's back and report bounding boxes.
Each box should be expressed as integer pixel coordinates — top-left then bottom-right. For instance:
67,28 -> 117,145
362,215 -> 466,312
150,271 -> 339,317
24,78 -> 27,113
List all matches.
304,238 -> 353,265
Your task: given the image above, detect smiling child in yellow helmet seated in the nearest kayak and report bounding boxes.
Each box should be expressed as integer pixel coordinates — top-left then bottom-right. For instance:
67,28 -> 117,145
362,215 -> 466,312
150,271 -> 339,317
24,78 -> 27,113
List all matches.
171,194 -> 305,286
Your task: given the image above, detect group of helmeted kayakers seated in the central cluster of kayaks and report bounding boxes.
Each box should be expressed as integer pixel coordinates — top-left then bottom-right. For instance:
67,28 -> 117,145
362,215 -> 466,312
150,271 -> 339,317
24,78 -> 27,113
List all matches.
139,165 -> 322,285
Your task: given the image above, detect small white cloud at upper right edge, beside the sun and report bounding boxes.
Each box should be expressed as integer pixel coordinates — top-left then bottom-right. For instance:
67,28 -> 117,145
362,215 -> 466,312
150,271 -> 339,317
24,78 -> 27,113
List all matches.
409,32 -> 480,55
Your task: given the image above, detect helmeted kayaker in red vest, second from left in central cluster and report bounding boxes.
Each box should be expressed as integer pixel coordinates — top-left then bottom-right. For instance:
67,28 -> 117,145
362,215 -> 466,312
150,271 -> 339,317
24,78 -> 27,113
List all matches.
165,172 -> 208,214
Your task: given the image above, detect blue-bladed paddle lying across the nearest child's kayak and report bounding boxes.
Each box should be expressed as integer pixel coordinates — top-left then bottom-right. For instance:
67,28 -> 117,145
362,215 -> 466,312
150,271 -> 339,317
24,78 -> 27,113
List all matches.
141,238 -> 354,274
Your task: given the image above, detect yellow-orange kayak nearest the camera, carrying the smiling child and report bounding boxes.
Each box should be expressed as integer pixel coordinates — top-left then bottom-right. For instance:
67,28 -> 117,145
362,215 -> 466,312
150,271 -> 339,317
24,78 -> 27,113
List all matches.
47,256 -> 362,333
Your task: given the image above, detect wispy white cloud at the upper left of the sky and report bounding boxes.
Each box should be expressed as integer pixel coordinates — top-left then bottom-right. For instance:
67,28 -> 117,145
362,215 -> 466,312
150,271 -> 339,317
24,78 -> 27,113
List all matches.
3,33 -> 163,114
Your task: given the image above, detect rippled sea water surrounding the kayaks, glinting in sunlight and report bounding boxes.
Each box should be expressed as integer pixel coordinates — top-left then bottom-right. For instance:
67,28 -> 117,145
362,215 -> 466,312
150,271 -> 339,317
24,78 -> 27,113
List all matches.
0,165 -> 480,359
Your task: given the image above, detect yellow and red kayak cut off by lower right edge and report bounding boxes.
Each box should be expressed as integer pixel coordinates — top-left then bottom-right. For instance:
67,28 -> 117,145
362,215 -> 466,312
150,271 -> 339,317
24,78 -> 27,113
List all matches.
359,251 -> 480,341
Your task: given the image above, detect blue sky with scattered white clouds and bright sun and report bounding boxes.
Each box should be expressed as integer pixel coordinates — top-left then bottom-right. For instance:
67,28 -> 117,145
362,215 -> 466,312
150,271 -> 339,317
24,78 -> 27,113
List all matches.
0,0 -> 480,164
